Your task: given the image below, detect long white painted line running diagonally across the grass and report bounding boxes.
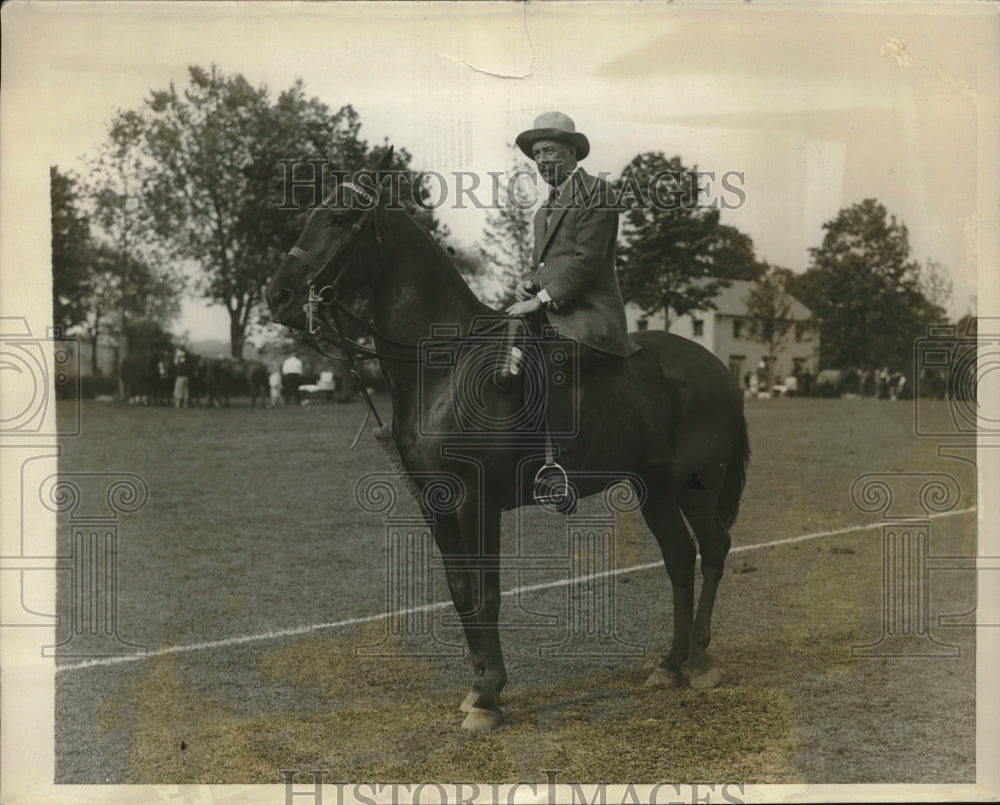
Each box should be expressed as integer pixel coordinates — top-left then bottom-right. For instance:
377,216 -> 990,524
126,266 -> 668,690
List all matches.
56,506 -> 976,673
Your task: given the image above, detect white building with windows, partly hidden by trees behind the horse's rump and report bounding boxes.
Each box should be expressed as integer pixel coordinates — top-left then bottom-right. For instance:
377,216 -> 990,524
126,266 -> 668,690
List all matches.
625,280 -> 819,385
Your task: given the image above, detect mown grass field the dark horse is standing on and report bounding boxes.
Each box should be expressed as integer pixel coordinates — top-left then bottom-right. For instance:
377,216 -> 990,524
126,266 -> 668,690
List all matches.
55,399 -> 976,784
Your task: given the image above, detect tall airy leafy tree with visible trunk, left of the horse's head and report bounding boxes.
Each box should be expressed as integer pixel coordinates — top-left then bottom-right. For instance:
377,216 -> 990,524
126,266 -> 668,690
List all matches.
137,66 -> 286,357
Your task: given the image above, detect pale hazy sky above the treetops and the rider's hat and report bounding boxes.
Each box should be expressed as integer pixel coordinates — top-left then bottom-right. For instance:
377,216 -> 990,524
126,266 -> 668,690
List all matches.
0,2 -> 1000,339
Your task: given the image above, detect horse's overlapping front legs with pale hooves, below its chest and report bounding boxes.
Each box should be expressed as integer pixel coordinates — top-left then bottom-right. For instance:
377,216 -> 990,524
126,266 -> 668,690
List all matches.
435,500 -> 507,730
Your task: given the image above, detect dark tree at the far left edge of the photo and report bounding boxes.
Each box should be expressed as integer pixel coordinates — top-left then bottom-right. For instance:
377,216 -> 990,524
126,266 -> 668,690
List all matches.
49,165 -> 91,330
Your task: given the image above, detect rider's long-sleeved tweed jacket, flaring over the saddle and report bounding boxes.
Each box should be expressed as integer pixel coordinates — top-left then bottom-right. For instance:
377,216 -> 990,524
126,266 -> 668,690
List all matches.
532,168 -> 640,357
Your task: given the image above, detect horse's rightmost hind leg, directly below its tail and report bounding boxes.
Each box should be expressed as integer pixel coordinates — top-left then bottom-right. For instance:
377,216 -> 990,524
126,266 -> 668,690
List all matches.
680,487 -> 730,688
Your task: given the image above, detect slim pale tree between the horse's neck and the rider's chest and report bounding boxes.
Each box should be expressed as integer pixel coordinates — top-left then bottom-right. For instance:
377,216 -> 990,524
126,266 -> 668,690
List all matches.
480,146 -> 535,308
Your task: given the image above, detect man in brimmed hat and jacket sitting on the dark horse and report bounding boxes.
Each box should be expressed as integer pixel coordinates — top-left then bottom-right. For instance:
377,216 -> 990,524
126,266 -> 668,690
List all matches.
507,112 -> 640,508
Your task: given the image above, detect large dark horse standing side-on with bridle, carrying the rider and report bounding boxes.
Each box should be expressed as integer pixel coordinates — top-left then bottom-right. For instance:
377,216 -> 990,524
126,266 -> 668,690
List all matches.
267,149 -> 750,729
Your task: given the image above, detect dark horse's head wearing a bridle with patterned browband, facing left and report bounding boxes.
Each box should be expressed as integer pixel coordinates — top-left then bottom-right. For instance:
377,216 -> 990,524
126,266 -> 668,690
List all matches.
265,148 -> 392,329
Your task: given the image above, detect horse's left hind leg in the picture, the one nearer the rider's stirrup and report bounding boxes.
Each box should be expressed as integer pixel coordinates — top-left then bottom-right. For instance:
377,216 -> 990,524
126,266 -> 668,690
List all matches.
642,473 -> 695,687
